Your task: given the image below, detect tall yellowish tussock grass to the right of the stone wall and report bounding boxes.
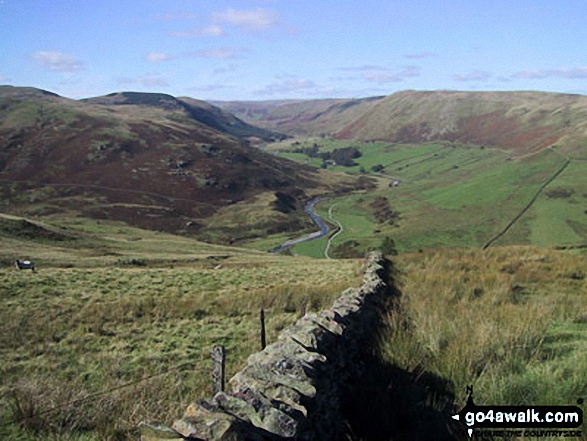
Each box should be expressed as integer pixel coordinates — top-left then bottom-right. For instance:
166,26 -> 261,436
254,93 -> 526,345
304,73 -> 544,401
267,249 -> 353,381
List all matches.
381,247 -> 587,416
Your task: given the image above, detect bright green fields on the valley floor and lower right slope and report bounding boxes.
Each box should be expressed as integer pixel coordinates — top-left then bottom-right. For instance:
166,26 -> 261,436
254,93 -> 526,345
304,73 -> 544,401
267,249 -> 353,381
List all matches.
262,138 -> 587,257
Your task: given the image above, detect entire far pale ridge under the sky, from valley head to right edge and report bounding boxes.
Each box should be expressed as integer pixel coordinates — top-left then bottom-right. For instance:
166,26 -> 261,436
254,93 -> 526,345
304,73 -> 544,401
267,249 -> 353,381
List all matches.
222,91 -> 587,156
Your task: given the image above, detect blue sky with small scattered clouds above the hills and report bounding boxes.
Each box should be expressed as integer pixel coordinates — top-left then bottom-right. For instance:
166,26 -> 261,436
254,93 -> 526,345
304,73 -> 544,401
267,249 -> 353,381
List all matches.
0,0 -> 587,100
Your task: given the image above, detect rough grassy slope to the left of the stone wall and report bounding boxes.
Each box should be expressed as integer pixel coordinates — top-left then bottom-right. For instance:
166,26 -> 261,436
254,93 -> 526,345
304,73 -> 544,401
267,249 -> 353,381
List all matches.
0,215 -> 362,440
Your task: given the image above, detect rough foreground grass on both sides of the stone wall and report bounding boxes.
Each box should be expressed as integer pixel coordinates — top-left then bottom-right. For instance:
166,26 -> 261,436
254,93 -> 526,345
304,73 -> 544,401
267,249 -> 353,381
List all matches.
0,215 -> 587,441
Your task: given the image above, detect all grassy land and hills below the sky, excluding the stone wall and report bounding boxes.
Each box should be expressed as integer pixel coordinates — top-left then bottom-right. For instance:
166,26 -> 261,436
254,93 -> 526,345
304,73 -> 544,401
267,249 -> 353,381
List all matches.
0,86 -> 587,441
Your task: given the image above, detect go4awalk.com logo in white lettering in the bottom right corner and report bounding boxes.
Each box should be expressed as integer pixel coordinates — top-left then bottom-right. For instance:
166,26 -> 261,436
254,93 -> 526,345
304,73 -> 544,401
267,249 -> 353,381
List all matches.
452,386 -> 583,439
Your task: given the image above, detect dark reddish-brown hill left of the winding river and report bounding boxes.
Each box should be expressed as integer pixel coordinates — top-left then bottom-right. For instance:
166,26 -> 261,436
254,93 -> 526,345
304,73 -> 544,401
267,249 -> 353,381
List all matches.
0,87 -> 336,237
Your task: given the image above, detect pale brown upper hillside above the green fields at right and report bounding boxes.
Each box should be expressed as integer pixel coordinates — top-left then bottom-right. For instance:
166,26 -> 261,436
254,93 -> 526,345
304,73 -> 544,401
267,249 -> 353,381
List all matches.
335,91 -> 587,153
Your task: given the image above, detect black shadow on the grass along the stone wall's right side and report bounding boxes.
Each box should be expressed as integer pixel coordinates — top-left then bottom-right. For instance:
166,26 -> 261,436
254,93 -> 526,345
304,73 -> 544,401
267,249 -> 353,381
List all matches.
341,262 -> 468,441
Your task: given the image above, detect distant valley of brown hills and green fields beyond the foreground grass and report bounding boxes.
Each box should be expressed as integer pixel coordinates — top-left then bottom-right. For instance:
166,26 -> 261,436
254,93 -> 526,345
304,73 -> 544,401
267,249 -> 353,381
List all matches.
0,87 -> 587,257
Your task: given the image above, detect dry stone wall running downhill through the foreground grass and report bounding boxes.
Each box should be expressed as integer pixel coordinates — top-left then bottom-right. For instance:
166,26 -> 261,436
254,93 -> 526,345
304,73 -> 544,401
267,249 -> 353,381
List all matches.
141,253 -> 390,441
